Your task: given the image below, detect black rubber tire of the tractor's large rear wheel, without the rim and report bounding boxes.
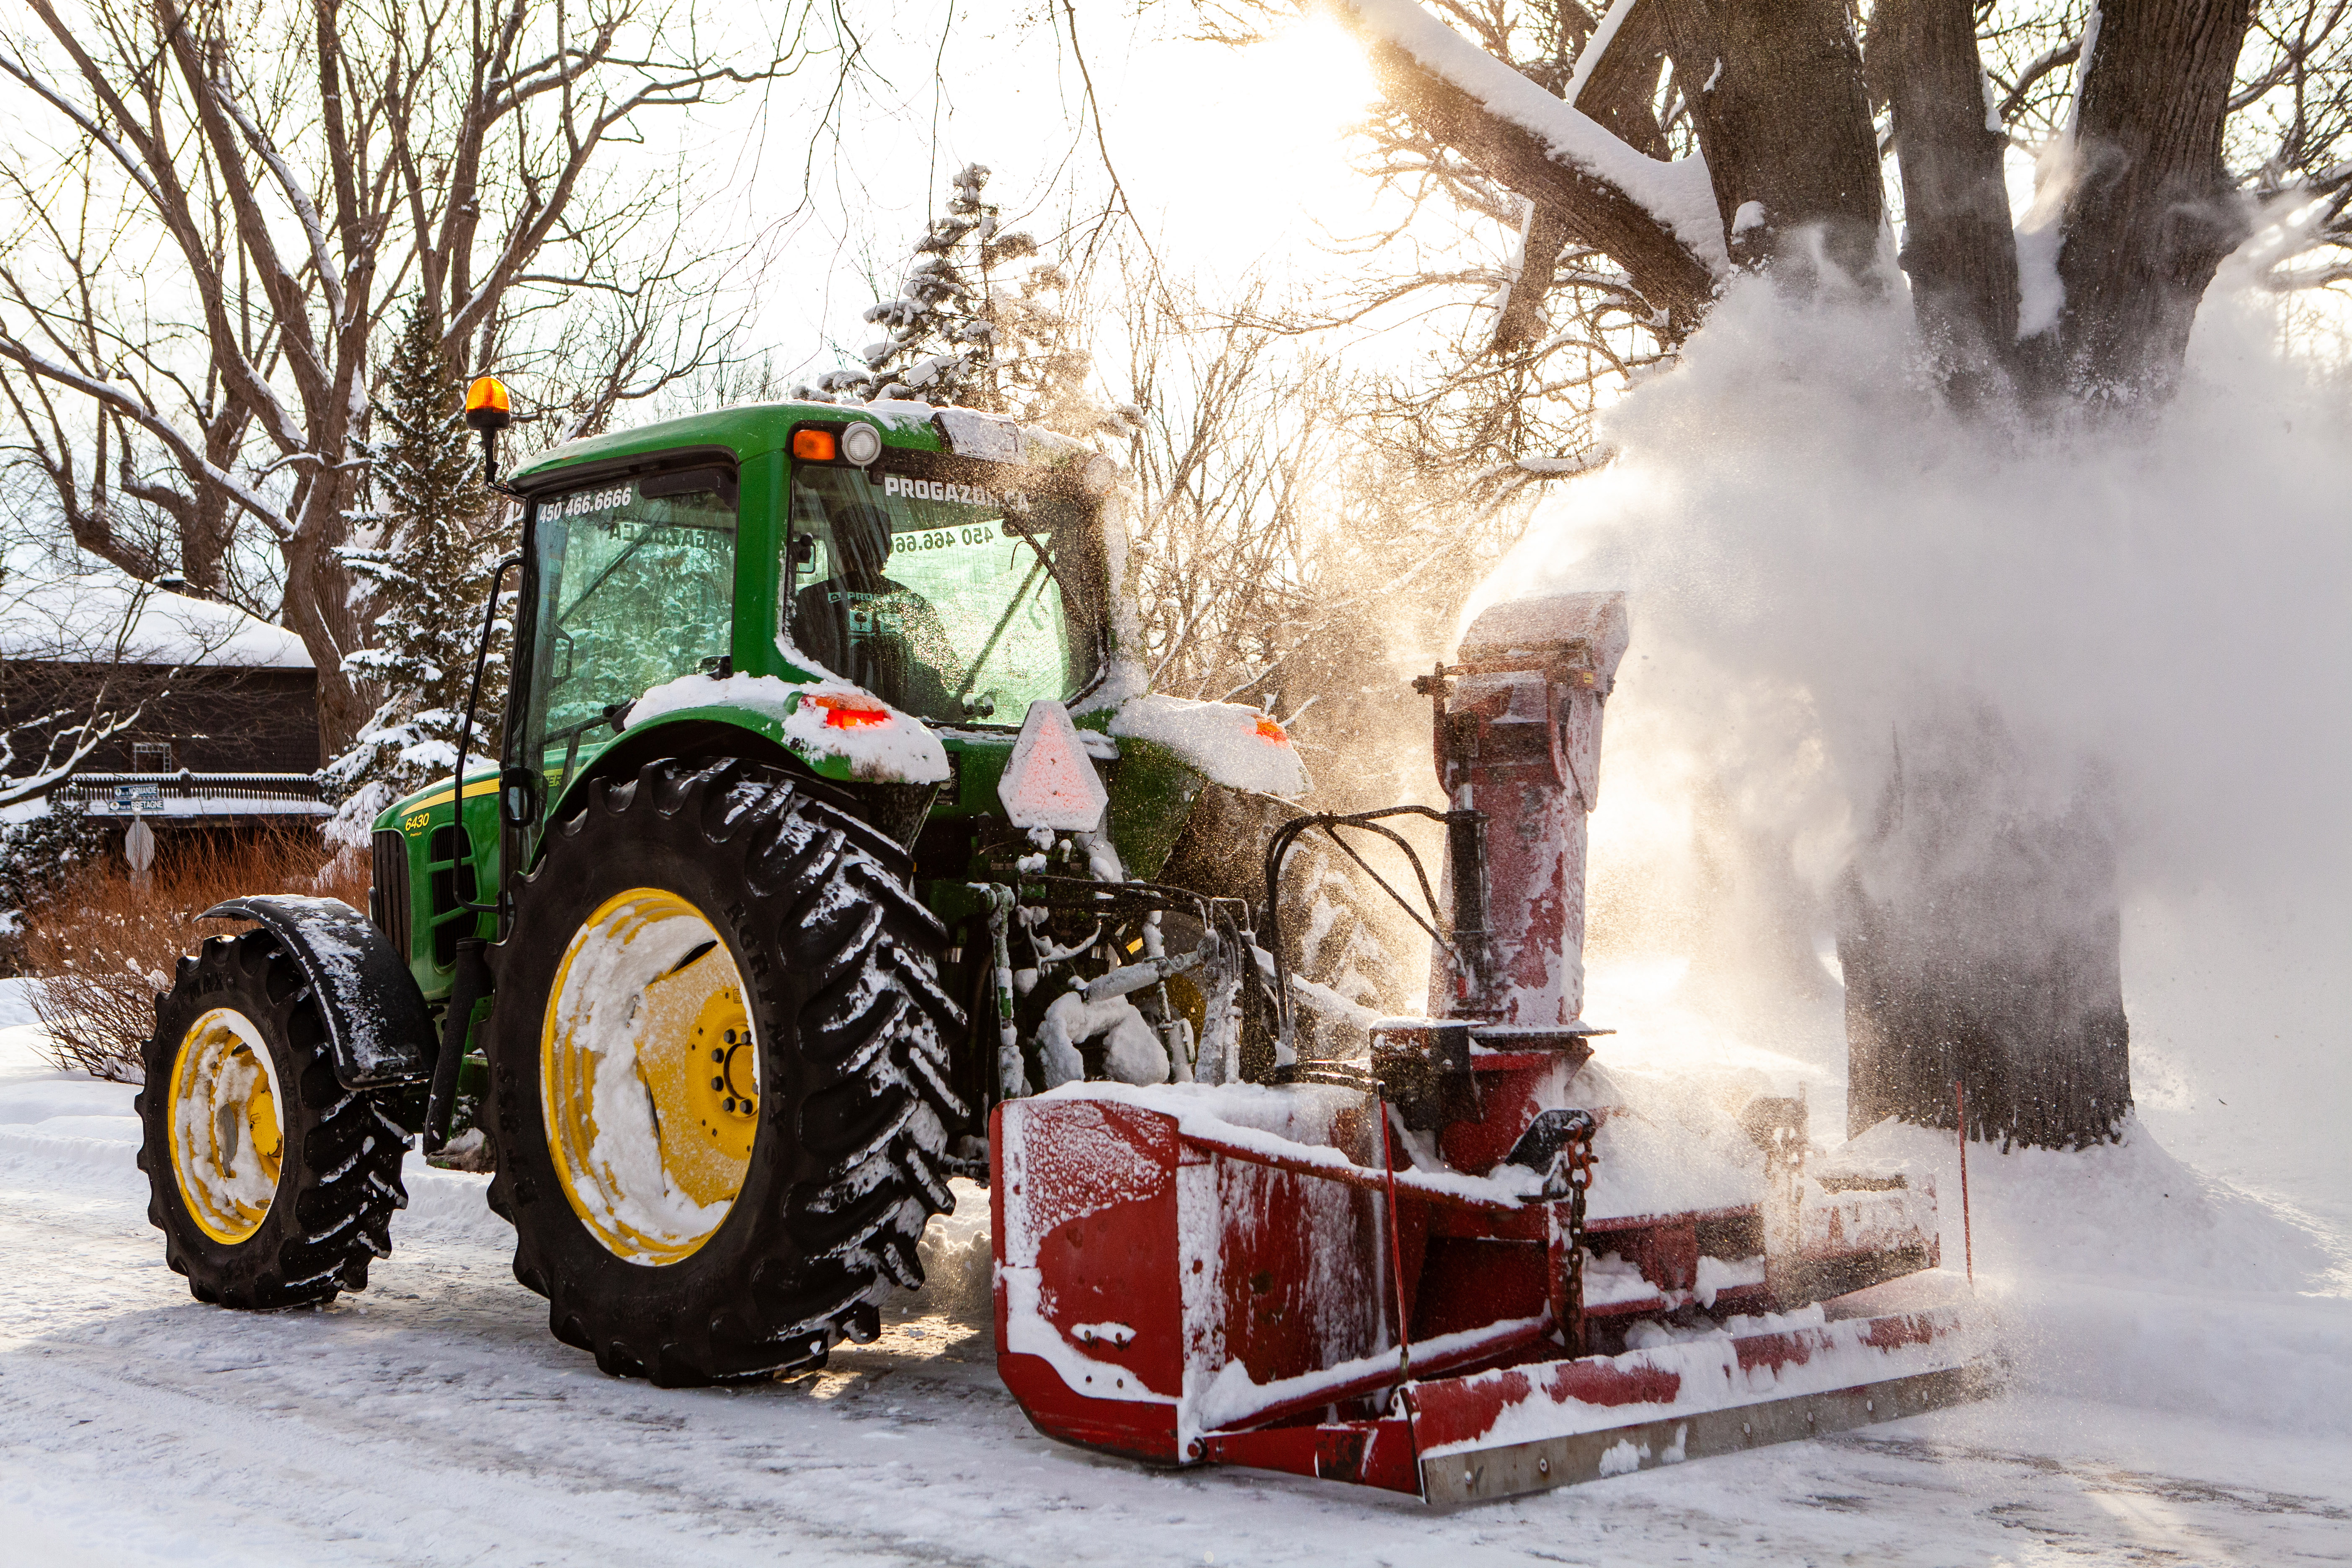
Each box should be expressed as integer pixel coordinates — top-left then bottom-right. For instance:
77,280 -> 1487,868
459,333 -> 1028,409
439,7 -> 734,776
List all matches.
489,759 -> 967,1385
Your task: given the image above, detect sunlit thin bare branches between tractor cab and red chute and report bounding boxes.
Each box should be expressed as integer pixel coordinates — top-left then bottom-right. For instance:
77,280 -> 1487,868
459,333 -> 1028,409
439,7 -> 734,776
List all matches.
1119,279 -> 1522,804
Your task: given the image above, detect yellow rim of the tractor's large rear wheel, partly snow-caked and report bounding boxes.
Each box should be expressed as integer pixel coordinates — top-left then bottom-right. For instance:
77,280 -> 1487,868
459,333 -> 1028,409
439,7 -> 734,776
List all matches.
539,889 -> 760,1265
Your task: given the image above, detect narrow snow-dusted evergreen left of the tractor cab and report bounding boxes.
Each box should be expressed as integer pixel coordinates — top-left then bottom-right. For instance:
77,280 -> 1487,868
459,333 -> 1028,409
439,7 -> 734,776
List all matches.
325,299 -> 508,846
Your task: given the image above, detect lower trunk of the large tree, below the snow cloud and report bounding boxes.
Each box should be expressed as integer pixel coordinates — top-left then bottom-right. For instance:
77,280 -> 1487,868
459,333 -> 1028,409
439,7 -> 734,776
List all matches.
1837,714 -> 2131,1150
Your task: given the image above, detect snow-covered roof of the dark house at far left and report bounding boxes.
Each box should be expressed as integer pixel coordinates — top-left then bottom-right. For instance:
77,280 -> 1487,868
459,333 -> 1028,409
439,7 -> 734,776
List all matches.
0,571 -> 313,670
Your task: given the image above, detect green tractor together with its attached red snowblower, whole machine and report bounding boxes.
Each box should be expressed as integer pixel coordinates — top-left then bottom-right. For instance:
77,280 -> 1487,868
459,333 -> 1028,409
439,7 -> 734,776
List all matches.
124,395 -> 1971,1502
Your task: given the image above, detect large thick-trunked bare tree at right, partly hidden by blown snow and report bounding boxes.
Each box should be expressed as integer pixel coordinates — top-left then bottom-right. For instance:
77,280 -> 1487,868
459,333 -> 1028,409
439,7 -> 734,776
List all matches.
1197,0 -> 2352,1142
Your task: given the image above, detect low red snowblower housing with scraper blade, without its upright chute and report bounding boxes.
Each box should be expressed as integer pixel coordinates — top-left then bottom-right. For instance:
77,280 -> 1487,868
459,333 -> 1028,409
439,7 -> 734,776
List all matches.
990,1084 -> 1973,1502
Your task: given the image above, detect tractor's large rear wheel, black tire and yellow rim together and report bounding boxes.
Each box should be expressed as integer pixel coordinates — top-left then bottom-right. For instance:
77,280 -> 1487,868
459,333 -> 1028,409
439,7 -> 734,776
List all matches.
489,759 -> 967,1387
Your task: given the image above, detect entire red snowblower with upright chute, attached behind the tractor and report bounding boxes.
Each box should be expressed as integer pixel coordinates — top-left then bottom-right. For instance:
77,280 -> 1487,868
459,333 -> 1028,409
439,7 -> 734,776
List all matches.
990,595 -> 1985,1502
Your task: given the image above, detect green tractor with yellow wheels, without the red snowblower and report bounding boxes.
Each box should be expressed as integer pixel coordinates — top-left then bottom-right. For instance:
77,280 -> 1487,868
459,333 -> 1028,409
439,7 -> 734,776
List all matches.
141,386 -> 1397,1385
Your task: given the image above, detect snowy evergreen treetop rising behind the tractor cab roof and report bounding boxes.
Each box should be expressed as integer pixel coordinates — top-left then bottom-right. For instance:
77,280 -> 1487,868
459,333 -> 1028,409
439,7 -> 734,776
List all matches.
799,165 -> 1124,433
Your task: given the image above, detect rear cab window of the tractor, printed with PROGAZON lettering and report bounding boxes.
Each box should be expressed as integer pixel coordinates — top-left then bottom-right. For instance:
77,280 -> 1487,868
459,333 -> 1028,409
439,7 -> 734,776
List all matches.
781,463 -> 1101,724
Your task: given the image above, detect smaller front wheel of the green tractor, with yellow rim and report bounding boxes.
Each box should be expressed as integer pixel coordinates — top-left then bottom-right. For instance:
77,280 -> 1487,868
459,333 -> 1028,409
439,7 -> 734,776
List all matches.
137,931 -> 409,1307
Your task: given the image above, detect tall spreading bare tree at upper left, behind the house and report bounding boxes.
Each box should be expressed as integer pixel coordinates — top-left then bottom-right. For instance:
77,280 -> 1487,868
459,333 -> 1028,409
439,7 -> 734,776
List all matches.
0,0 -> 840,752
